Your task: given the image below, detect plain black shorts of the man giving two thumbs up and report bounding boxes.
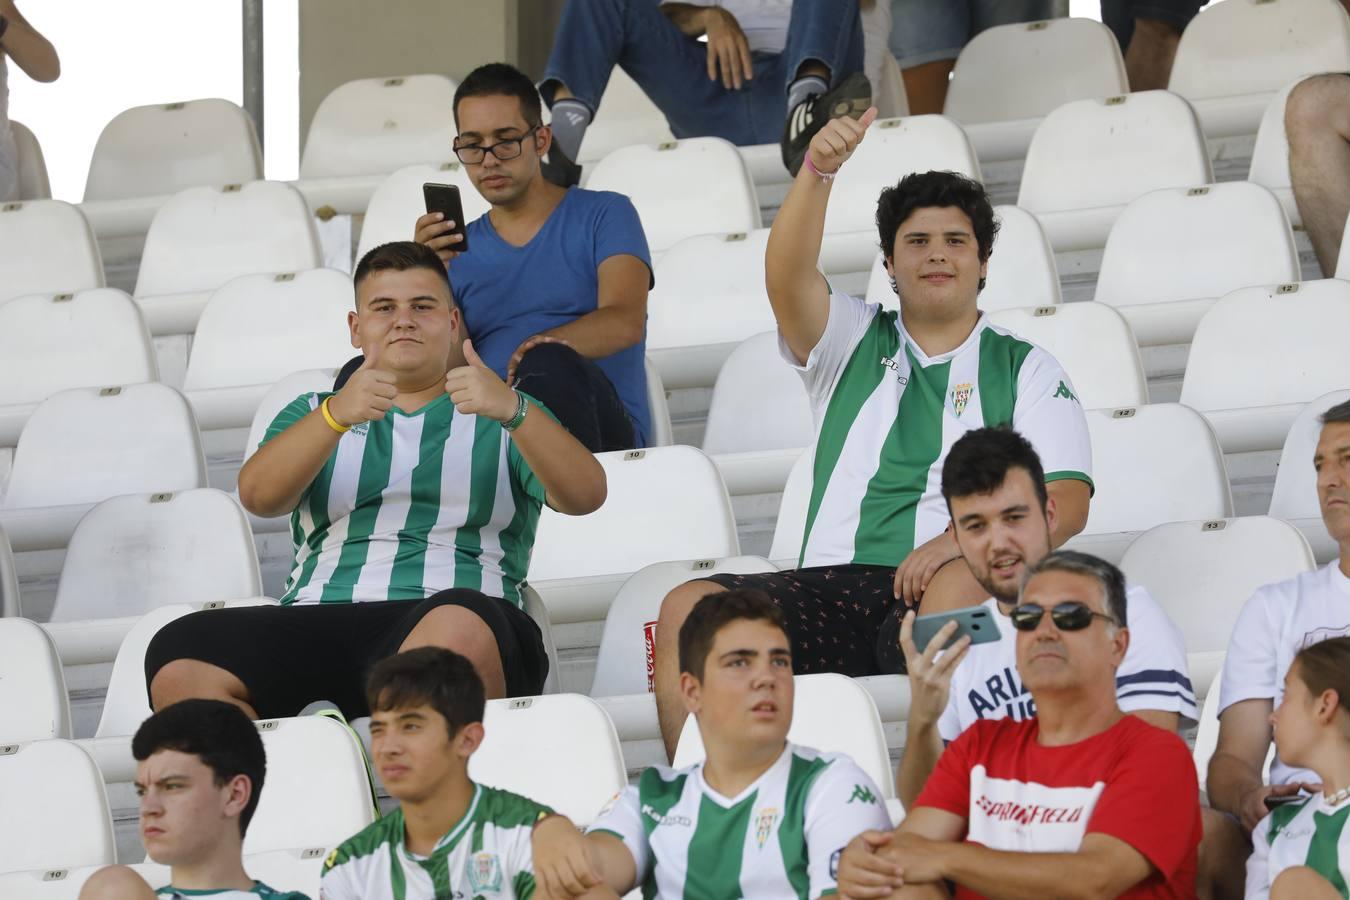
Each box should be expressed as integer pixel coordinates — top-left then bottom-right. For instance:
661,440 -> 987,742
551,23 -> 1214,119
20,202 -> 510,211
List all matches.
146,588 -> 548,719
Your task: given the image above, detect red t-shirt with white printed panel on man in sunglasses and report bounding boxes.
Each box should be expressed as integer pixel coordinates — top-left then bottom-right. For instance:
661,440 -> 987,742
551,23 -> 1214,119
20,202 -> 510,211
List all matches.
915,715 -> 1202,897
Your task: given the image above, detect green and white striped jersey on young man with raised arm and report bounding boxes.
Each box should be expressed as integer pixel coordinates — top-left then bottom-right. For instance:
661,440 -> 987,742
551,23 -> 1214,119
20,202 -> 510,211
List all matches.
779,290 -> 1092,567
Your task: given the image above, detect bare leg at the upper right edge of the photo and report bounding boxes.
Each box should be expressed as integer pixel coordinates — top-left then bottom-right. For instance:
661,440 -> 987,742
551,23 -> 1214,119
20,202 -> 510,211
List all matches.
1284,74 -> 1350,278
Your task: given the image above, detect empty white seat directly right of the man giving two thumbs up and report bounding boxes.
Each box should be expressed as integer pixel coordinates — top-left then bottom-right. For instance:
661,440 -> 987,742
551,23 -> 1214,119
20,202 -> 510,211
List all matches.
529,445 -> 740,623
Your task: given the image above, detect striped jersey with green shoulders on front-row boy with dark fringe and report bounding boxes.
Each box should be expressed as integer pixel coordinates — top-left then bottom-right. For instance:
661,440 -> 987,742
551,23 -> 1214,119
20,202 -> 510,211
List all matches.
320,784 -> 552,900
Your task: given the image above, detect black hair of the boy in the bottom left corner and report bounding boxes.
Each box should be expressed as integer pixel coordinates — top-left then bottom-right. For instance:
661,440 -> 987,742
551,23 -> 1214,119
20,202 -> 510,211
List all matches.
131,699 -> 267,838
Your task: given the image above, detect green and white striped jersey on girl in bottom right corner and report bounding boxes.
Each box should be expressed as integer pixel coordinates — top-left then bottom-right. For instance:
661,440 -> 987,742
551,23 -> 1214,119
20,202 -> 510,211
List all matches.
1246,791 -> 1350,900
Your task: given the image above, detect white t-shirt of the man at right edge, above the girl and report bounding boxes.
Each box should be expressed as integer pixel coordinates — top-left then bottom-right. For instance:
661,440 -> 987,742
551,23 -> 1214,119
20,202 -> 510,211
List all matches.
1219,561 -> 1350,784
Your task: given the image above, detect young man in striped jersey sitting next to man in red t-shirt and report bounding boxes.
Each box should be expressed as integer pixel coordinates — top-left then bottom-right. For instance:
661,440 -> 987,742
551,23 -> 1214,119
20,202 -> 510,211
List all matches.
535,590 -> 890,900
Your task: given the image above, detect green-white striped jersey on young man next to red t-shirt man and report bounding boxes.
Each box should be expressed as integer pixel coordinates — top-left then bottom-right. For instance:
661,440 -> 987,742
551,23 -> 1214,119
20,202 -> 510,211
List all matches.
589,743 -> 891,900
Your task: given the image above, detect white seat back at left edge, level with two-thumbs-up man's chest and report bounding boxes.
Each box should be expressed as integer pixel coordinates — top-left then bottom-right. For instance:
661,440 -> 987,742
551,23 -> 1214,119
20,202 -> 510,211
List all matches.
0,383 -> 207,509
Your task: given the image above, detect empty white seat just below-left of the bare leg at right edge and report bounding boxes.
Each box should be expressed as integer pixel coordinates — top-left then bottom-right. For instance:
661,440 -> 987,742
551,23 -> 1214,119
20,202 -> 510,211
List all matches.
1094,181 -> 1299,345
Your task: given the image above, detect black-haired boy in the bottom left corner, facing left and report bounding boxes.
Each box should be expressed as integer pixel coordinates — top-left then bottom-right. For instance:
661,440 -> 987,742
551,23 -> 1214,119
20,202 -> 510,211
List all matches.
80,700 -> 306,900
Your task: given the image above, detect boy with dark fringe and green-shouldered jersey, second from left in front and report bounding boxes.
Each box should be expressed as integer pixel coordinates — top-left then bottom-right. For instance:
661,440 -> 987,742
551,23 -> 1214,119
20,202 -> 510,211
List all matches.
321,646 -> 552,900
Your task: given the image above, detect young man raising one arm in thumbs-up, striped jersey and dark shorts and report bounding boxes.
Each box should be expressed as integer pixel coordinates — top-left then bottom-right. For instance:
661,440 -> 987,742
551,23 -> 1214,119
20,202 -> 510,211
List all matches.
655,109 -> 1092,752
